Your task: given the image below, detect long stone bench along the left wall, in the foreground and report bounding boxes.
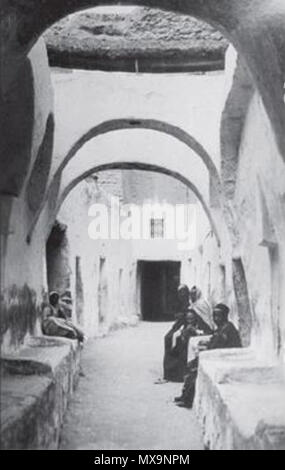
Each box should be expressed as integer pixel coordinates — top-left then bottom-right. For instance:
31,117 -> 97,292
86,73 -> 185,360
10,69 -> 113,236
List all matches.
1,337 -> 80,449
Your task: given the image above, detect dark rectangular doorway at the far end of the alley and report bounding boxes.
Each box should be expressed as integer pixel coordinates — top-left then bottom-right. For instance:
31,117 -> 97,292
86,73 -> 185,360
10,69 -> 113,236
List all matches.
139,261 -> 181,321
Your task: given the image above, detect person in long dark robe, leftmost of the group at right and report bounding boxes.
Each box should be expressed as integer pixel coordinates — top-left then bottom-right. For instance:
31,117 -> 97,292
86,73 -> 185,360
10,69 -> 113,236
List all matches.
161,285 -> 212,383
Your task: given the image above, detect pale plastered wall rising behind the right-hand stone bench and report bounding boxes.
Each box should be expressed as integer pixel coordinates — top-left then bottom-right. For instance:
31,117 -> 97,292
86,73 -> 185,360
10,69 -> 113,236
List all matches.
234,93 -> 285,359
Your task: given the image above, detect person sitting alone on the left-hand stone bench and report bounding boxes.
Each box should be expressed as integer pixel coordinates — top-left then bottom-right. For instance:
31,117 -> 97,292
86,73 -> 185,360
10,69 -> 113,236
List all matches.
42,292 -> 84,342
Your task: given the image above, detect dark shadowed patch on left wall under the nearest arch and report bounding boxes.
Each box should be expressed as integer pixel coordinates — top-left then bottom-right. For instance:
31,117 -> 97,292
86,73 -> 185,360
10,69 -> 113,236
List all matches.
0,59 -> 34,196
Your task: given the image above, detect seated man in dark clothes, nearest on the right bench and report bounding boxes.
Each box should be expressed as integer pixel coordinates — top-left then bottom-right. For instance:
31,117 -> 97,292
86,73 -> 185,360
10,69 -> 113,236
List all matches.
174,304 -> 241,408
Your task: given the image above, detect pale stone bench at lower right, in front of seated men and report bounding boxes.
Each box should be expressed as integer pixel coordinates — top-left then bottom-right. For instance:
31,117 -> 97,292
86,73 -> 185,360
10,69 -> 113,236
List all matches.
194,349 -> 285,450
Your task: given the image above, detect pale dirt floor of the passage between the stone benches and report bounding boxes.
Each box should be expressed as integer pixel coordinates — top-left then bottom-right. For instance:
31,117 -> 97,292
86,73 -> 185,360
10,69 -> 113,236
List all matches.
61,323 -> 202,450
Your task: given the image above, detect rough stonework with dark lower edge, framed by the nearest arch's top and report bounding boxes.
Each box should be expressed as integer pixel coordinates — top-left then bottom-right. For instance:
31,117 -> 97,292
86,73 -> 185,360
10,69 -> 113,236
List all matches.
45,8 -> 227,71
